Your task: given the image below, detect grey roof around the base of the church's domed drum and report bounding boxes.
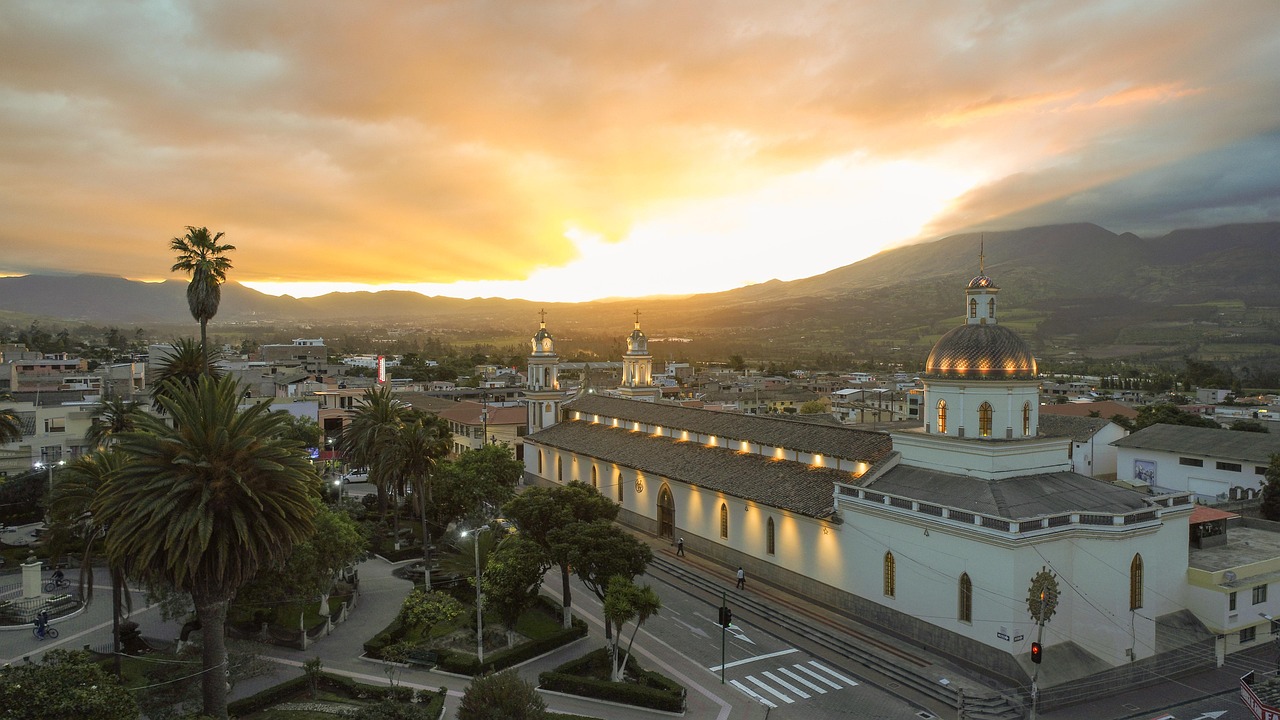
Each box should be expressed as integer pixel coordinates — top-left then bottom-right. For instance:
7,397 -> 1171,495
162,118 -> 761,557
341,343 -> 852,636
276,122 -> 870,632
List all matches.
868,465 -> 1149,520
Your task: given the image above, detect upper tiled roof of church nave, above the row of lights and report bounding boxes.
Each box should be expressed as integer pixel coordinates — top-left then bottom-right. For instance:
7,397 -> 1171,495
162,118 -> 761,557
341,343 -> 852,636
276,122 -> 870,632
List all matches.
564,395 -> 893,462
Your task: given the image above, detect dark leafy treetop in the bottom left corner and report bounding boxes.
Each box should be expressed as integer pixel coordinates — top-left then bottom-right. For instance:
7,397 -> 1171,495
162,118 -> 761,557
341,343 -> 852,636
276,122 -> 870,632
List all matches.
0,650 -> 138,720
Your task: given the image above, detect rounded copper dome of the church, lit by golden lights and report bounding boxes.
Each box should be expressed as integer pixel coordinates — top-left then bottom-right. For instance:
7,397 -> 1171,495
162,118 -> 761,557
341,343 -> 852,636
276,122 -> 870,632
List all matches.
924,324 -> 1036,380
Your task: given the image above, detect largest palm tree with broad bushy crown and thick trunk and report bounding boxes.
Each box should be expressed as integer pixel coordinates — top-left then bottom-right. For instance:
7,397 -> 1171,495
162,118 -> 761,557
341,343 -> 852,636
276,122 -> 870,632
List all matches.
91,375 -> 320,717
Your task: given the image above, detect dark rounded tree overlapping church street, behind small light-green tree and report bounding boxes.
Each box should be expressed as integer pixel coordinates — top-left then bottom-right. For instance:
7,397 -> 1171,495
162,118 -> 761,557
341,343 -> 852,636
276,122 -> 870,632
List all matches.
552,520 -> 653,641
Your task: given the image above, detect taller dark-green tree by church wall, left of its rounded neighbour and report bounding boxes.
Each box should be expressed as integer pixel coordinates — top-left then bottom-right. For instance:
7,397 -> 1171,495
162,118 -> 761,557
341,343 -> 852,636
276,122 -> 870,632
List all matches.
503,480 -> 618,628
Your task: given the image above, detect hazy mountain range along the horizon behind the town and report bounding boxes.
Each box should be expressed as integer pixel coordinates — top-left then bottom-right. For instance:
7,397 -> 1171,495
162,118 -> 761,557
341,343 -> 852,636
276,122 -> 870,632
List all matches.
0,223 -> 1280,359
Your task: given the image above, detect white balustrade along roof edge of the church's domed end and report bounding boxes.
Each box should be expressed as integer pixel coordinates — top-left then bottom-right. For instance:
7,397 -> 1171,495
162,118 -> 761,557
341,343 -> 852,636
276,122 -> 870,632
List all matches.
836,484 -> 1192,536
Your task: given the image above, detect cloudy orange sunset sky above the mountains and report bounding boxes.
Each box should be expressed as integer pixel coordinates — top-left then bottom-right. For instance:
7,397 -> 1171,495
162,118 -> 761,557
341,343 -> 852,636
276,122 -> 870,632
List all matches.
0,0 -> 1280,301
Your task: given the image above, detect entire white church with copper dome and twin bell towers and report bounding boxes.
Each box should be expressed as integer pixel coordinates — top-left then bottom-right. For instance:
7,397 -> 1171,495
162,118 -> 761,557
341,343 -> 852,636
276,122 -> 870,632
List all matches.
525,264 -> 1213,687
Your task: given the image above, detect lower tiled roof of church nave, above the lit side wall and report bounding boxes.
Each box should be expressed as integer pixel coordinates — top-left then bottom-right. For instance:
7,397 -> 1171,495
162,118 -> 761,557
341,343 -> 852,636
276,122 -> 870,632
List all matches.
525,420 -> 852,518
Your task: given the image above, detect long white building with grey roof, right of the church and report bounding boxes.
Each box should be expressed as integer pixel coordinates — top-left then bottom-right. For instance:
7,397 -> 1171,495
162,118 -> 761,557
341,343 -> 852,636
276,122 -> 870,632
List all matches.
1112,425 -> 1280,501
